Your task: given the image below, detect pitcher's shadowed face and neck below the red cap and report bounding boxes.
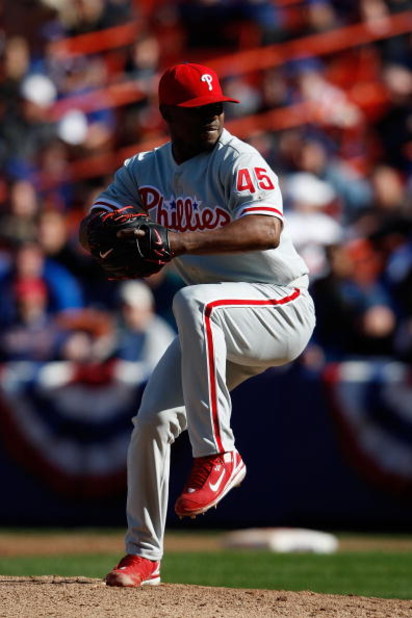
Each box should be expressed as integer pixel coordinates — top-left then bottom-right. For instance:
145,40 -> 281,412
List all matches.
165,103 -> 224,162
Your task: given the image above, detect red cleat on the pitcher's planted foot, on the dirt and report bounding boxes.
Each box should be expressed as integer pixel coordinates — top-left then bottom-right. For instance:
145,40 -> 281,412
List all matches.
105,554 -> 160,588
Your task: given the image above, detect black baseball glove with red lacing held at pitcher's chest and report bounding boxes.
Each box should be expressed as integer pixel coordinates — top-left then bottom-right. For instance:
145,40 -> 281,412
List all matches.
80,206 -> 173,279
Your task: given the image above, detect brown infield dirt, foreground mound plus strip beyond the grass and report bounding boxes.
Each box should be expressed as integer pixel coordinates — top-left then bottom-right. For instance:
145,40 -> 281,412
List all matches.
0,534 -> 412,618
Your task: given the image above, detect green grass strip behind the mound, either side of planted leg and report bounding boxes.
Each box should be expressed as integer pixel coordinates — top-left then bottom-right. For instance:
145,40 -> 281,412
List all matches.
0,550 -> 412,599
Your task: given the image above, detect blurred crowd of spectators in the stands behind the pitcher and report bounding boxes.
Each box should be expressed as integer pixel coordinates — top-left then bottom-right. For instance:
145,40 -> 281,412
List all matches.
0,0 -> 412,373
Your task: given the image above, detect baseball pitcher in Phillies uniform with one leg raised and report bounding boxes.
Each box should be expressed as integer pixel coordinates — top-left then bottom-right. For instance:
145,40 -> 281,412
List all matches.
80,63 -> 315,586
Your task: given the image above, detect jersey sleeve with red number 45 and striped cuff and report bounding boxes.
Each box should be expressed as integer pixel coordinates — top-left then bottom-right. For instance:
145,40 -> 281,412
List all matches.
227,150 -> 283,222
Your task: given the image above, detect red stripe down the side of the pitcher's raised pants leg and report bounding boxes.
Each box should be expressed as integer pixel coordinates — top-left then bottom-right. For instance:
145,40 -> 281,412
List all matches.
203,288 -> 300,453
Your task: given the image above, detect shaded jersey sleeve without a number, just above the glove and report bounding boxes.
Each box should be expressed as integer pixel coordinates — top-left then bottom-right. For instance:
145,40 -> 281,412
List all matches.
92,159 -> 142,210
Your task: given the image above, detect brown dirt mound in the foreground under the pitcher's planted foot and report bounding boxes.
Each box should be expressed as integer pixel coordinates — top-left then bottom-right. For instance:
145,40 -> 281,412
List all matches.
0,576 -> 412,618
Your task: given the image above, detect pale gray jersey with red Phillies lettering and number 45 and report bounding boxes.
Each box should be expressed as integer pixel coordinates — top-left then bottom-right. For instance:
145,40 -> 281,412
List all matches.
94,129 -> 308,285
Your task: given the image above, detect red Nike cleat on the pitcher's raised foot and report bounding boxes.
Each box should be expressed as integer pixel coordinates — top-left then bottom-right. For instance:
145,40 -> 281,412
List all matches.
175,451 -> 246,517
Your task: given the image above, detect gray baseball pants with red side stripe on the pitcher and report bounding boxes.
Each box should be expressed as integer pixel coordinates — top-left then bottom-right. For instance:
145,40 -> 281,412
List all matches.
122,278 -> 315,560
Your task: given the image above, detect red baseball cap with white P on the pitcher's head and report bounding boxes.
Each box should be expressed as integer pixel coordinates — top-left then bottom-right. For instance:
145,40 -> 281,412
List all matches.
159,62 -> 239,107
